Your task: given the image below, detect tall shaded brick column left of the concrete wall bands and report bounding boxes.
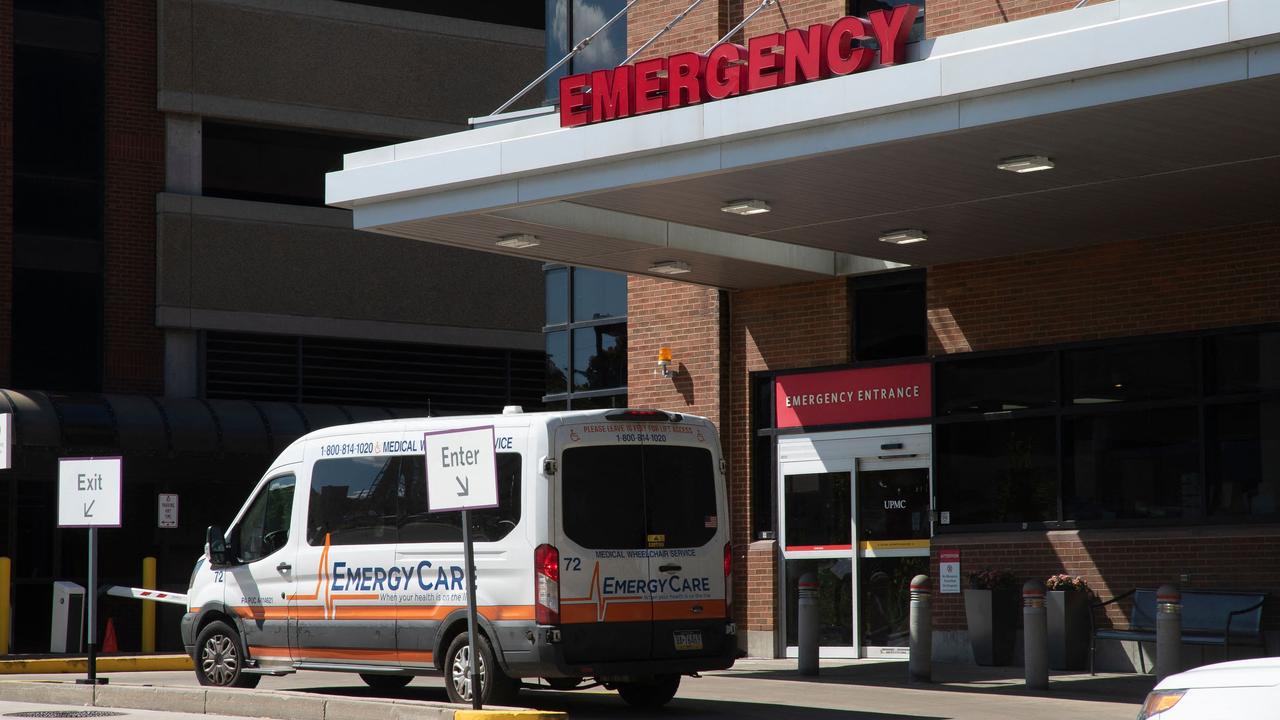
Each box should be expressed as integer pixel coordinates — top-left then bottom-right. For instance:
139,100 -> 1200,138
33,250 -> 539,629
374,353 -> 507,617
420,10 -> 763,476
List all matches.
102,0 -> 164,395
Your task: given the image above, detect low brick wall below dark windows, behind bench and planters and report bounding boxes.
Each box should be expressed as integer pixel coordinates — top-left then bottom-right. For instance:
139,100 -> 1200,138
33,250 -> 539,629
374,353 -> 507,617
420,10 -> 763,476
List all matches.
929,525 -> 1280,630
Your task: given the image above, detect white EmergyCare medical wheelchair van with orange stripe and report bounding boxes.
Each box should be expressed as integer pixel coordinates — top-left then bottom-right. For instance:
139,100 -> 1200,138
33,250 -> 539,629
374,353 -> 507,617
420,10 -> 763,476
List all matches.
182,410 -> 740,706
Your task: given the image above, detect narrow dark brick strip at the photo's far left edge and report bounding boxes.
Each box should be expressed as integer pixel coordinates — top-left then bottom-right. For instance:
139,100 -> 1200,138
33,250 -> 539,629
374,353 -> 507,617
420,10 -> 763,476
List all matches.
0,0 -> 13,387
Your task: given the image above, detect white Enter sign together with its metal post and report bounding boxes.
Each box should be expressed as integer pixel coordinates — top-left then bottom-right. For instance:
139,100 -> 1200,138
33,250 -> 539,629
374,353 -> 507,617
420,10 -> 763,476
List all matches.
422,425 -> 498,710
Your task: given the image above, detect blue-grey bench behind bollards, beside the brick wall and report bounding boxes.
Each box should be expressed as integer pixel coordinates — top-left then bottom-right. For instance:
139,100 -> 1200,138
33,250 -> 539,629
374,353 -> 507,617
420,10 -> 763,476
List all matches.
1089,588 -> 1267,675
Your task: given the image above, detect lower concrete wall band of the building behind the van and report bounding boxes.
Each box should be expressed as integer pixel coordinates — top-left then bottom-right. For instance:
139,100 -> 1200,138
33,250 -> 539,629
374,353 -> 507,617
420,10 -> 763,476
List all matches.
156,193 -> 544,348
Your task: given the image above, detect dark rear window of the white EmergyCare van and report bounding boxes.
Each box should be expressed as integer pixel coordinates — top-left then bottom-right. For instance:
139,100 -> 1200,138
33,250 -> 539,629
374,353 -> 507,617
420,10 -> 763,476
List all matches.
561,445 -> 719,550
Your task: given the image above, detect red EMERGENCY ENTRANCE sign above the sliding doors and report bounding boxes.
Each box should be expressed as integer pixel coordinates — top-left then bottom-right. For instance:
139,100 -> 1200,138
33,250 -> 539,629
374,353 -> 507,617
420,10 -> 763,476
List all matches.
773,363 -> 933,428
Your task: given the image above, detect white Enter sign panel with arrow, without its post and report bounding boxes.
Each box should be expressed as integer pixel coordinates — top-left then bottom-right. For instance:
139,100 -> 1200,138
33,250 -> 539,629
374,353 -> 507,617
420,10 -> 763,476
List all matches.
422,425 -> 498,512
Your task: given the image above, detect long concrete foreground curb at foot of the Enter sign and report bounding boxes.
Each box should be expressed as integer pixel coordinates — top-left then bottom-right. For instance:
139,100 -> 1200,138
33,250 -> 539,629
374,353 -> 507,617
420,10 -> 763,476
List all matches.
0,680 -> 568,720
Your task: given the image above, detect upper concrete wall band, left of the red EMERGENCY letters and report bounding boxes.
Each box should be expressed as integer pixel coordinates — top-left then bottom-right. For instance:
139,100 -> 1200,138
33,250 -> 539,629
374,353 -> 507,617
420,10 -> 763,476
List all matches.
157,0 -> 544,137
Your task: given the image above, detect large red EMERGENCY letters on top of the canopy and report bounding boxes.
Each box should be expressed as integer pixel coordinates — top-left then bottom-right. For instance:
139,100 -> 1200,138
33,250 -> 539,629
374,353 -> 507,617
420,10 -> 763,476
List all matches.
559,5 -> 918,128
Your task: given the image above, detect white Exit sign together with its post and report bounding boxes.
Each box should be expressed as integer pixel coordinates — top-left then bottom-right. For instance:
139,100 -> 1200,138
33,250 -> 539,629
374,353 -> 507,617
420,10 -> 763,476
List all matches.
58,457 -> 123,685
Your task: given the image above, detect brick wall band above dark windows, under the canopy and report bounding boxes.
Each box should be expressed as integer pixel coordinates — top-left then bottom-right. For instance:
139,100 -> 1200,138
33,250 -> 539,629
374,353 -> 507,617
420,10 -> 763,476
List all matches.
928,220 -> 1280,354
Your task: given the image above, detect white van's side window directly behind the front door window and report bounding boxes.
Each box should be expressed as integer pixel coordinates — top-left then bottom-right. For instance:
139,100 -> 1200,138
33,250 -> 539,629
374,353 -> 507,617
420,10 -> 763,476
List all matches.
307,455 -> 401,546
